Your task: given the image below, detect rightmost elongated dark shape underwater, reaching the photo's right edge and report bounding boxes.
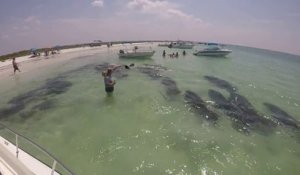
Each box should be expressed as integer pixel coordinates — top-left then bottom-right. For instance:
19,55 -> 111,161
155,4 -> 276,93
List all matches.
264,103 -> 300,129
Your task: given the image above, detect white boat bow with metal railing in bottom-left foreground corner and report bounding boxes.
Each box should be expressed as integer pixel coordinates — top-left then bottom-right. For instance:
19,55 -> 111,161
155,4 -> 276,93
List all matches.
0,123 -> 74,175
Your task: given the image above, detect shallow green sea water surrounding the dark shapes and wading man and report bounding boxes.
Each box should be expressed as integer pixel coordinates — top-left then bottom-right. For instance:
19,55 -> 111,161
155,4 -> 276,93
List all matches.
0,46 -> 300,175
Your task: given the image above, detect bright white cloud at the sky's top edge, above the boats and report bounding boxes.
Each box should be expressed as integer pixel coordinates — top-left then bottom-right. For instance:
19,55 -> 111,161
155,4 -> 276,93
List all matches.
127,0 -> 202,22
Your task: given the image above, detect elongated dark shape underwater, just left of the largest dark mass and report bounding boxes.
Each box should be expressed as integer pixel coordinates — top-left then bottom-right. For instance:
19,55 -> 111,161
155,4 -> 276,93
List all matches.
184,91 -> 218,122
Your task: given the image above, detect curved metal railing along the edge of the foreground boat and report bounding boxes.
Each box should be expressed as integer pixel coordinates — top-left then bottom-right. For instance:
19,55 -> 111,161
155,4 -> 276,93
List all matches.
0,122 -> 74,175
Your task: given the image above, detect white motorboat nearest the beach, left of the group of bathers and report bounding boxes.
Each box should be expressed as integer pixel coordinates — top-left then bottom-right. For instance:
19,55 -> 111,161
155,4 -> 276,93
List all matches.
118,46 -> 155,58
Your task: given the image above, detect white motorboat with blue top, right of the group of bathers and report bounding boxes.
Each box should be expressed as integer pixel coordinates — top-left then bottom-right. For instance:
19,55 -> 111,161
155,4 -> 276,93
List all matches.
194,45 -> 232,57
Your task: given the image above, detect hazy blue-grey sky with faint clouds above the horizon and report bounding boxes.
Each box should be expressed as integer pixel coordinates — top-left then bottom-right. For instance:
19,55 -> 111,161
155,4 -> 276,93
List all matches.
0,0 -> 300,55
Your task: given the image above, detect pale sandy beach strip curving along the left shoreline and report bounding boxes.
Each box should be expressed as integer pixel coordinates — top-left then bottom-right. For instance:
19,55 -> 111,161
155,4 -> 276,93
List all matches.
0,43 -> 158,79
